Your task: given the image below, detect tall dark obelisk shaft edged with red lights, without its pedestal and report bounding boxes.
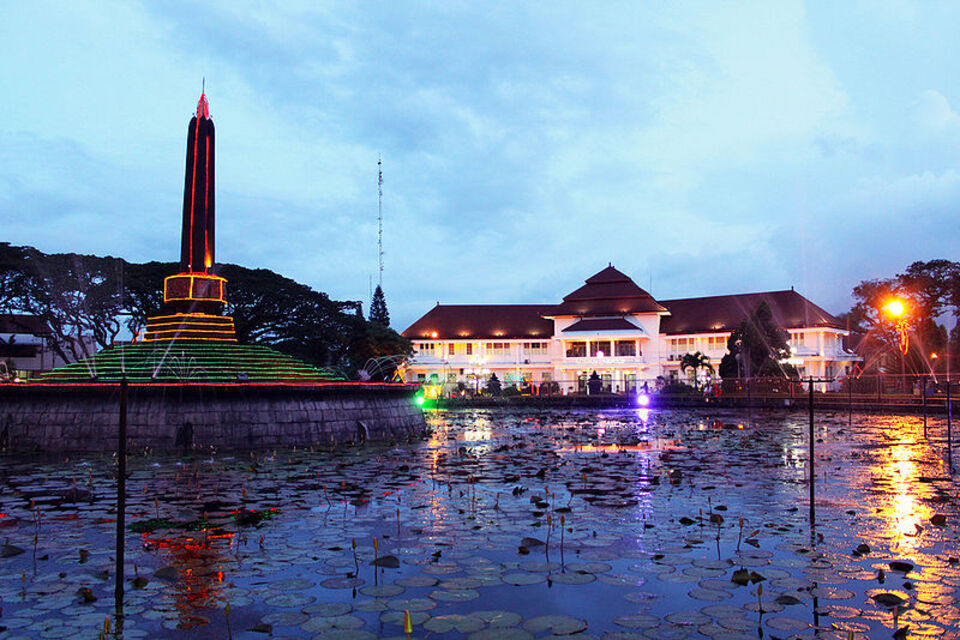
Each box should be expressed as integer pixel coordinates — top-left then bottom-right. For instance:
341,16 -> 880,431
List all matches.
180,93 -> 215,274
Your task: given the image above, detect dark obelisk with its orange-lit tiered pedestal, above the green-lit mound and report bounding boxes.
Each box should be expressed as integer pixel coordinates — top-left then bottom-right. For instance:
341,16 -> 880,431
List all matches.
144,94 -> 236,342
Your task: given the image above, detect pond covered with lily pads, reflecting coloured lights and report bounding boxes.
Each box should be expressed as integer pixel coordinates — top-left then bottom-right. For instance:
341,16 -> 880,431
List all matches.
0,410 -> 960,640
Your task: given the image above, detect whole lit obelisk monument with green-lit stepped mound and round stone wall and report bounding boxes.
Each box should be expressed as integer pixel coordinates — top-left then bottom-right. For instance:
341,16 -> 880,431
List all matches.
0,94 -> 424,451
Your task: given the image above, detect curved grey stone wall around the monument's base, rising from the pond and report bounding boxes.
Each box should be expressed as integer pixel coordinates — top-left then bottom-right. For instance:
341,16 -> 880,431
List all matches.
0,384 -> 425,452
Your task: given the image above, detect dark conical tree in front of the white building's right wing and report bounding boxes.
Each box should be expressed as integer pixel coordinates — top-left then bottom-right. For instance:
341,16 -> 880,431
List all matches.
720,302 -> 796,378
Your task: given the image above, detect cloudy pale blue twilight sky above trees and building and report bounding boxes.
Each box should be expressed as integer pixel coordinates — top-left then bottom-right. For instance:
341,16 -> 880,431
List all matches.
0,0 -> 960,330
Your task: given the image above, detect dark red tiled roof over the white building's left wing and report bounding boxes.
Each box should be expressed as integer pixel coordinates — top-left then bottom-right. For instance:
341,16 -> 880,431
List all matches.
403,304 -> 553,340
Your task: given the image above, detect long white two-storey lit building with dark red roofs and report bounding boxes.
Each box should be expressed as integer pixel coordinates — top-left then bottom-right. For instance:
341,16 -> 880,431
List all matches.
403,266 -> 859,392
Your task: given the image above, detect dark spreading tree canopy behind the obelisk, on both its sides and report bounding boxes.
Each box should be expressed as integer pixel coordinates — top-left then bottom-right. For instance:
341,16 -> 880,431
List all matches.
0,243 -> 412,377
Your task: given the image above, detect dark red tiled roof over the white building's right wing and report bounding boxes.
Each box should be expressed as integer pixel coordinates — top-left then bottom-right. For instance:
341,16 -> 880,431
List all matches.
660,289 -> 844,334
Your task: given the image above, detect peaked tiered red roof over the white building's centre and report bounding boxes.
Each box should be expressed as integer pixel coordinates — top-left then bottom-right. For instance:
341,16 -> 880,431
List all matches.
549,265 -> 666,316
